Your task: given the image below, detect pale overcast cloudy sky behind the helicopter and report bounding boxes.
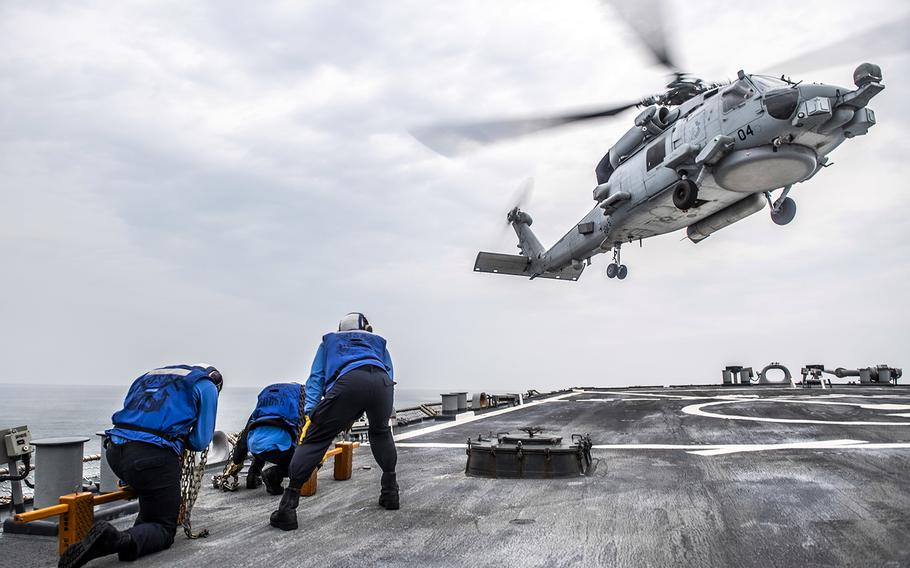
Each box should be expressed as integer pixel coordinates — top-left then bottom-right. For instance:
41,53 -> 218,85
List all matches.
0,0 -> 910,392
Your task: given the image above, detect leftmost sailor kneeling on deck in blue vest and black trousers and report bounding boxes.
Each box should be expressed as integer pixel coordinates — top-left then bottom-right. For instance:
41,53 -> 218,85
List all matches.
59,365 -> 222,568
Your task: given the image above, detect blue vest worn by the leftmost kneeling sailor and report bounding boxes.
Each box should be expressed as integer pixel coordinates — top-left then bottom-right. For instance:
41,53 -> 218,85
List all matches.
108,365 -> 214,442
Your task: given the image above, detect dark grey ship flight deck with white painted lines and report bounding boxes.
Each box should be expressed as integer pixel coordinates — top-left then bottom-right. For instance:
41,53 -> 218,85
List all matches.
0,386 -> 910,567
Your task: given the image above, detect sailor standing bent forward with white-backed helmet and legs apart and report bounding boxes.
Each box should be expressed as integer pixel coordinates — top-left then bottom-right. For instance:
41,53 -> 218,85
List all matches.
269,313 -> 398,531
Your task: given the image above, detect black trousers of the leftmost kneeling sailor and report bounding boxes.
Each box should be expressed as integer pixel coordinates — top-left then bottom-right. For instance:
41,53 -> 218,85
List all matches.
107,442 -> 181,560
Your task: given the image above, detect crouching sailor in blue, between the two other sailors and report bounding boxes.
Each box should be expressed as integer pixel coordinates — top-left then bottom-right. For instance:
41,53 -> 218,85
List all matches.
228,383 -> 306,495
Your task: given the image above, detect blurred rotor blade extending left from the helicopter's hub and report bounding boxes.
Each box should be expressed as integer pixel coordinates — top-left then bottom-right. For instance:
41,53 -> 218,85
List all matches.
411,102 -> 638,157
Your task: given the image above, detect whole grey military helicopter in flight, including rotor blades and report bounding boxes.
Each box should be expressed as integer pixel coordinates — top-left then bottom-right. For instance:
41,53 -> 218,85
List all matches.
412,2 -> 908,281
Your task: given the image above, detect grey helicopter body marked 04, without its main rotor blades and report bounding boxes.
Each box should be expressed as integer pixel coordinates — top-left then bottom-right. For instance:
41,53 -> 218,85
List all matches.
488,64 -> 884,280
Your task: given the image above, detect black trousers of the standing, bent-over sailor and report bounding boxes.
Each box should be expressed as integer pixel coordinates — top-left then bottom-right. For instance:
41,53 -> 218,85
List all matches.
290,365 -> 398,488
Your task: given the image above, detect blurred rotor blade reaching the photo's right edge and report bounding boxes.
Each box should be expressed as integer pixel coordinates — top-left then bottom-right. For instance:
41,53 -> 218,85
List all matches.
762,14 -> 910,77
